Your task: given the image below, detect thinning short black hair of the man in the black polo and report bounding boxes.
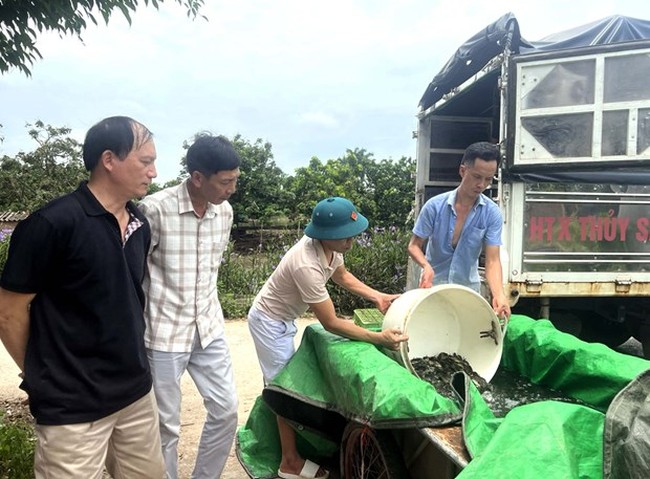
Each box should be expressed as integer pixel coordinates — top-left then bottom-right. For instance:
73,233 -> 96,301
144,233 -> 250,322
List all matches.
83,116 -> 153,171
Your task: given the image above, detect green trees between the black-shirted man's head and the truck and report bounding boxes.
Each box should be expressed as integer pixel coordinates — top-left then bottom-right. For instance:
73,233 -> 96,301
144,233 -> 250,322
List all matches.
144,133 -> 415,228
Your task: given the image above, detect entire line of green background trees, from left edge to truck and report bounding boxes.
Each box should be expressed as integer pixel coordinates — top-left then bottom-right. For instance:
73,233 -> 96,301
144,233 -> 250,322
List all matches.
0,121 -> 415,234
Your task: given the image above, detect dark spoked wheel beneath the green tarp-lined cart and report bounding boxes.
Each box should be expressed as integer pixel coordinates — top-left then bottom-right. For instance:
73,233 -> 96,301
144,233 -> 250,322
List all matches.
341,422 -> 410,479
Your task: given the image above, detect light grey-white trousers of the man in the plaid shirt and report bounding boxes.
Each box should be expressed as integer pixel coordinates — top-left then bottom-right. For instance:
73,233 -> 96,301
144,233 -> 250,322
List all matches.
147,333 -> 238,479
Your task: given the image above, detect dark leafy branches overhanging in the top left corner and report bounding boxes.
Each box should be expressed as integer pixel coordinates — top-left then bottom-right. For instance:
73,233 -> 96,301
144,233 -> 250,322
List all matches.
0,0 -> 204,75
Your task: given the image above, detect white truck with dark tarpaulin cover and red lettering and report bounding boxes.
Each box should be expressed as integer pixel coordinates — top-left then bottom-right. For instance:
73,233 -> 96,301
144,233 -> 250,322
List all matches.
408,13 -> 650,356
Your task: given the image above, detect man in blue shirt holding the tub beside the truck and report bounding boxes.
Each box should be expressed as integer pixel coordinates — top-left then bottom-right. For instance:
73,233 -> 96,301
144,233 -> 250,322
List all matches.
408,142 -> 510,317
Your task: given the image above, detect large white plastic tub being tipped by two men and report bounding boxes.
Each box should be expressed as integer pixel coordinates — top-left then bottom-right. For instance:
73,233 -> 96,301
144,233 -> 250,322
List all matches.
382,284 -> 503,382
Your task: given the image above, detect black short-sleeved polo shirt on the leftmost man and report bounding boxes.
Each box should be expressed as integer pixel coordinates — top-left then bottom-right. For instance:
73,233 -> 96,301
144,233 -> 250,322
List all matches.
0,182 -> 152,425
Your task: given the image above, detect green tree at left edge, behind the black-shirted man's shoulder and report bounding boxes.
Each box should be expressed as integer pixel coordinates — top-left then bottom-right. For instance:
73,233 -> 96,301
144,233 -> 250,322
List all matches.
0,121 -> 88,211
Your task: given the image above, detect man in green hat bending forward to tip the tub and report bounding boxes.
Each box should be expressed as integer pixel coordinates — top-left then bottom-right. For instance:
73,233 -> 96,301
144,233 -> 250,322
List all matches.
248,197 -> 408,479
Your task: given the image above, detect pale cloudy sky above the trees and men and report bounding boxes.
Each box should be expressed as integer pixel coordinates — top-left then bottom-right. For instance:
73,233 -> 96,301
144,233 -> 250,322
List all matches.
0,0 -> 650,183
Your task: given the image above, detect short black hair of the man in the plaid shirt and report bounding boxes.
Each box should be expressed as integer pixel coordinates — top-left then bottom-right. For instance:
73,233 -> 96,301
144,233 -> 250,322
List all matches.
186,133 -> 241,178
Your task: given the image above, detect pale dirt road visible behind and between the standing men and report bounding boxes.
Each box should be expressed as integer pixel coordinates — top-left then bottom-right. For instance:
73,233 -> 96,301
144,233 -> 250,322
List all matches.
0,319 -> 315,479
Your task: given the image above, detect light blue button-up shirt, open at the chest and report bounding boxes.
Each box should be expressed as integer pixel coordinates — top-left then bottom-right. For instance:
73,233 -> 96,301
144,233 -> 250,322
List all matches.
413,189 -> 503,291
